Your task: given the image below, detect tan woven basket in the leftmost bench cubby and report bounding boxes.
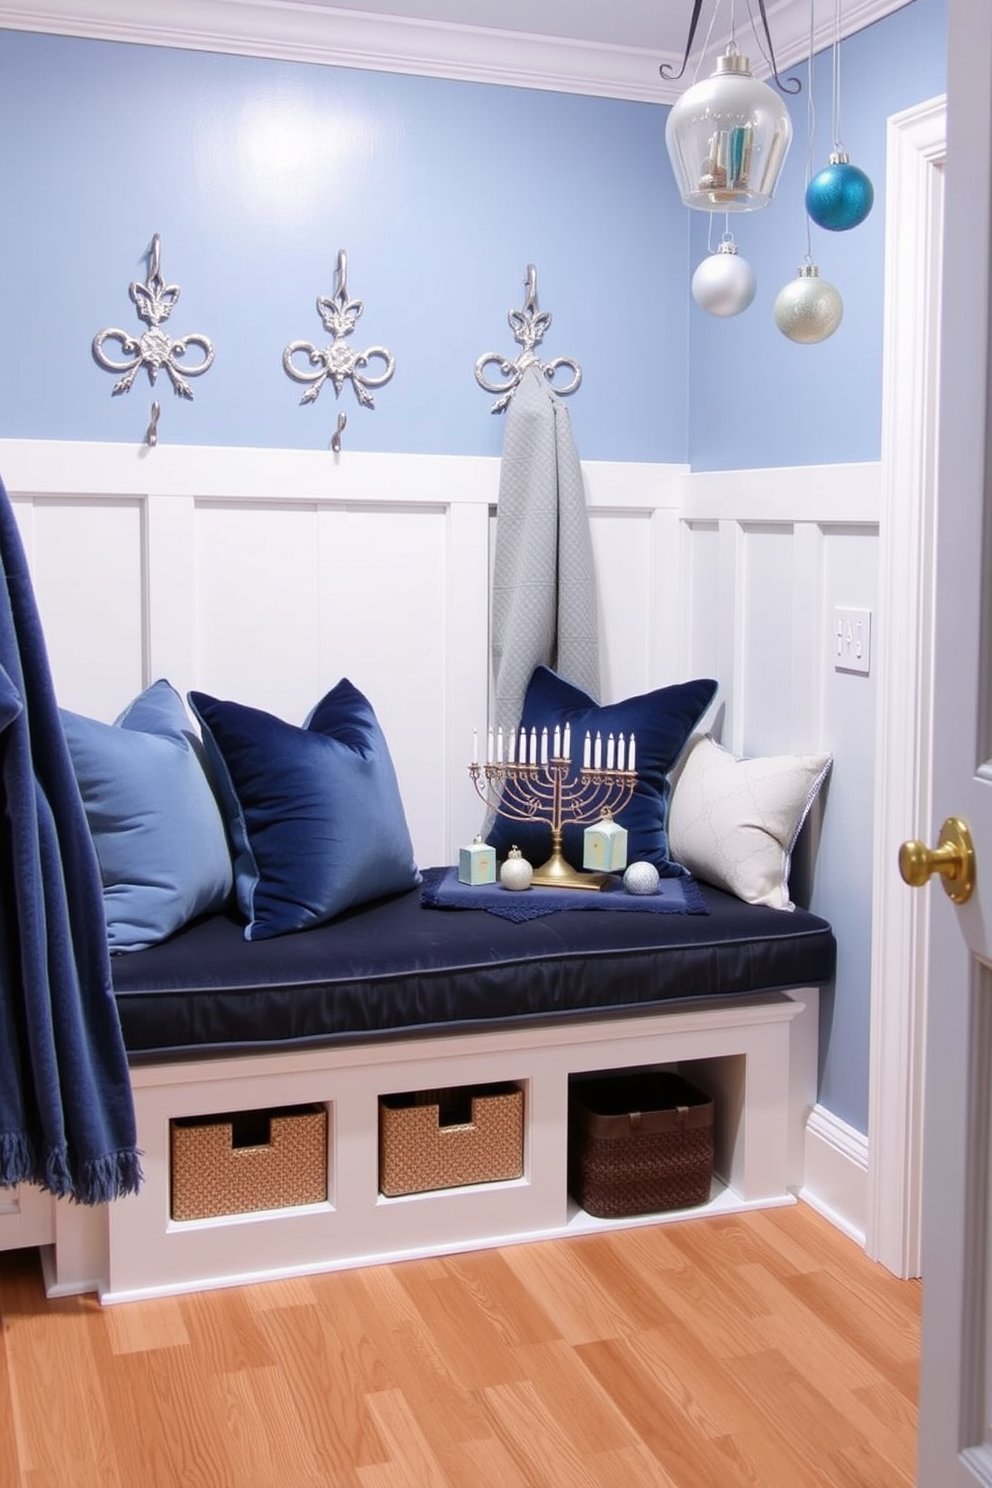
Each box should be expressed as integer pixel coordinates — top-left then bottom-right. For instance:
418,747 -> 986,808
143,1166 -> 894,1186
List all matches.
170,1106 -> 327,1219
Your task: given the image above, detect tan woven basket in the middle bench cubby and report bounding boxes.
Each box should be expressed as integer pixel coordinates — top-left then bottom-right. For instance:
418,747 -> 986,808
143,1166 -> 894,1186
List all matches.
379,1085 -> 524,1198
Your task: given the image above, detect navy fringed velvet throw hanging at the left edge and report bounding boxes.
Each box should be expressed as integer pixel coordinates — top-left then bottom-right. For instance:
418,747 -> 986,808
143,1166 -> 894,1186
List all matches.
0,482 -> 141,1204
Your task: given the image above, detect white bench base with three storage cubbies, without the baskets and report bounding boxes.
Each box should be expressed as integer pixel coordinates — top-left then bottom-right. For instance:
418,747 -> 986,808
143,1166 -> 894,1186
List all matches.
36,988 -> 817,1303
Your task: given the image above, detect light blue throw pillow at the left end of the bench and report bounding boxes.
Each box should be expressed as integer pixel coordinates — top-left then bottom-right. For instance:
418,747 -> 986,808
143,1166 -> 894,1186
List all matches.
61,680 -> 233,952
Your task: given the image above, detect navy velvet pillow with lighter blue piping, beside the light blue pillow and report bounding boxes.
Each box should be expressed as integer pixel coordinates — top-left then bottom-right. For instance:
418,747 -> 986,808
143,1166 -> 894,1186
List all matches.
189,677 -> 421,940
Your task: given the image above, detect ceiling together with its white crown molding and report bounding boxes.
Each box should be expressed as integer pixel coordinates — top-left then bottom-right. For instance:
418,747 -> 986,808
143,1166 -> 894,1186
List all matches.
0,0 -> 912,103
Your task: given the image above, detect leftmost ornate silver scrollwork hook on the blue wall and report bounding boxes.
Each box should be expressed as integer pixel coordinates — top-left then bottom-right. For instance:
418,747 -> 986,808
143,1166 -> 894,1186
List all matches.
92,232 -> 214,445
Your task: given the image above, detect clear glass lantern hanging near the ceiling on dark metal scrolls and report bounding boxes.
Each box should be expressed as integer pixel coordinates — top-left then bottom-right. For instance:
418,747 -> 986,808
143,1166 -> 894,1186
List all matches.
660,0 -> 802,211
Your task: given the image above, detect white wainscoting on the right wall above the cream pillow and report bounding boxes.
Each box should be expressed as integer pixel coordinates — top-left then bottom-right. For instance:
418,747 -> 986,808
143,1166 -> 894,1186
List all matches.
683,464 -> 880,754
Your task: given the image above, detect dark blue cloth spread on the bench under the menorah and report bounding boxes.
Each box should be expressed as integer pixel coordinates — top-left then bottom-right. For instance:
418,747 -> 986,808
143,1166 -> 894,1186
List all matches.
421,868 -> 709,924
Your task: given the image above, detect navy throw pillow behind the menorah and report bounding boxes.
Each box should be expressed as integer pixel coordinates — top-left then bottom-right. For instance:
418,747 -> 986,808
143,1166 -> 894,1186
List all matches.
488,667 -> 717,878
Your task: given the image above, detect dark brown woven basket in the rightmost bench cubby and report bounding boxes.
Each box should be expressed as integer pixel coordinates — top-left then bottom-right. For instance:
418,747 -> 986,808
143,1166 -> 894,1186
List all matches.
568,1070 -> 712,1219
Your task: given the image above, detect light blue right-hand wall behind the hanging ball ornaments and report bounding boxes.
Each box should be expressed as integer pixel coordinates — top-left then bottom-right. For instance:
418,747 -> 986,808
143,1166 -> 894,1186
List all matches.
686,0 -> 946,470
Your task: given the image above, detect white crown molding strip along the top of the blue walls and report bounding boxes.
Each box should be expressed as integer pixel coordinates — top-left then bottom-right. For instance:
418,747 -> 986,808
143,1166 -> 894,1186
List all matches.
0,0 -> 910,104
